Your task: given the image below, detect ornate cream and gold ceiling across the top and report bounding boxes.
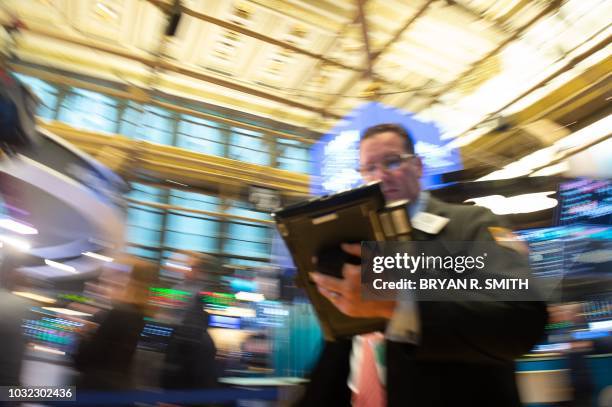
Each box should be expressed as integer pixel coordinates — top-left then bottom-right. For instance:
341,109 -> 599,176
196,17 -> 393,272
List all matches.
0,0 -> 612,145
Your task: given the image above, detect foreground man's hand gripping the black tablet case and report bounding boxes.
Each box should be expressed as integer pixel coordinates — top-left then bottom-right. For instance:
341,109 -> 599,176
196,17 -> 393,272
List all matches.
310,243 -> 395,319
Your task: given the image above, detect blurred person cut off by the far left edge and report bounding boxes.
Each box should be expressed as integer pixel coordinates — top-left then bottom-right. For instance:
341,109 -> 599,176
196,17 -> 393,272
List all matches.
0,249 -> 30,388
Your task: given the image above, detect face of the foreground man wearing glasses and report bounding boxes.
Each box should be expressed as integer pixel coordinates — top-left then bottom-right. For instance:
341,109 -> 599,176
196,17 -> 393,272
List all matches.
359,131 -> 423,202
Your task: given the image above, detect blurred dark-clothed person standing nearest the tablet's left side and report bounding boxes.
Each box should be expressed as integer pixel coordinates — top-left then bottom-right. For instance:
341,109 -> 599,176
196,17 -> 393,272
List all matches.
161,253 -> 218,389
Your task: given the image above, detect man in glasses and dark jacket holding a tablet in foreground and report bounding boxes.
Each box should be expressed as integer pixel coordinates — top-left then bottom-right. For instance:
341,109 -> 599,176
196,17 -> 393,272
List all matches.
312,124 -> 547,407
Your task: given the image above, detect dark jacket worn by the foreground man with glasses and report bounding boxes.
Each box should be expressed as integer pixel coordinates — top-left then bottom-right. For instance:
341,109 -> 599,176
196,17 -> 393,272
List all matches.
386,198 -> 547,407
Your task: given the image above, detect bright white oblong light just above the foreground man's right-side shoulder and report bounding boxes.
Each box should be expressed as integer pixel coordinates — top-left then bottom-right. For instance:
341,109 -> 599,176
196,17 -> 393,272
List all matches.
465,191 -> 558,215
